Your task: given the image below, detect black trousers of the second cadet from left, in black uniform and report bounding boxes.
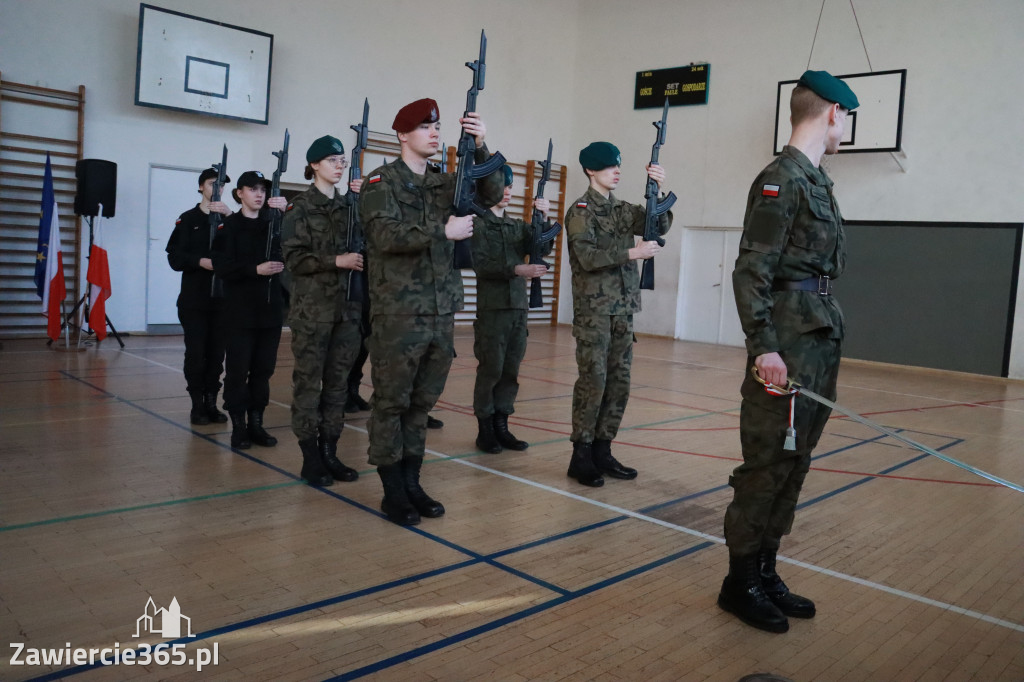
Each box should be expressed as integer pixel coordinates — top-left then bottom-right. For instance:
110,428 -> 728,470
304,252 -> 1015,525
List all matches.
224,327 -> 281,412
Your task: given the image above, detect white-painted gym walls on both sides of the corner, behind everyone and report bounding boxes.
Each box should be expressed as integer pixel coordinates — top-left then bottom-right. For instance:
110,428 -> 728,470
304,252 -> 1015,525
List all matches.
0,0 -> 1024,377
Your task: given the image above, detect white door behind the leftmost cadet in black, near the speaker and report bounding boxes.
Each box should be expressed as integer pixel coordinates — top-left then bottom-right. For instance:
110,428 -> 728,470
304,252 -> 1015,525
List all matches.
145,166 -> 202,326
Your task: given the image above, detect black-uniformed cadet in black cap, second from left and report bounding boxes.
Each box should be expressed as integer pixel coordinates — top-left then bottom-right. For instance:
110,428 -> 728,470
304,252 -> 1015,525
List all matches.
212,171 -> 288,450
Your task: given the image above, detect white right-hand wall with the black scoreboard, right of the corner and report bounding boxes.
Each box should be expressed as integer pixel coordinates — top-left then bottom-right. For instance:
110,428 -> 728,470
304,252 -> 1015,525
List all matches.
560,0 -> 1024,377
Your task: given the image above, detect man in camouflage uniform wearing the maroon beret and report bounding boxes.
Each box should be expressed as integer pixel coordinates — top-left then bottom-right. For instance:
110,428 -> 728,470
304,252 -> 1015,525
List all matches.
359,99 -> 502,525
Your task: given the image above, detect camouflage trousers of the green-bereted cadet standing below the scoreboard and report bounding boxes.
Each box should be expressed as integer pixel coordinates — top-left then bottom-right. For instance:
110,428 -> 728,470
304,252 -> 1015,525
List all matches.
570,314 -> 633,442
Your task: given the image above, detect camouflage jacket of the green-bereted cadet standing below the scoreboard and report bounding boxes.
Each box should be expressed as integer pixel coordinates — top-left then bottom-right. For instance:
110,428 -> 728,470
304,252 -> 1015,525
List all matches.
565,187 -> 672,315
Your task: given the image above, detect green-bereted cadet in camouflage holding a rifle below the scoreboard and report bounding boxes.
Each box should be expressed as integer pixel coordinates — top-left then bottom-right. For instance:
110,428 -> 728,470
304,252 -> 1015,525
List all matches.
565,142 -> 672,487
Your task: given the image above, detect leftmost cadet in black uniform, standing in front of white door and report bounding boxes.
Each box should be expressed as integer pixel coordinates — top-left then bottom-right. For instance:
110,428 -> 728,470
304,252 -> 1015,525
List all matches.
166,168 -> 231,425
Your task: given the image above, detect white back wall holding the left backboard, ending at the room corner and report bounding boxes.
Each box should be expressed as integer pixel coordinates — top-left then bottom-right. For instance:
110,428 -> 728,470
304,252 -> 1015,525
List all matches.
0,0 -> 579,331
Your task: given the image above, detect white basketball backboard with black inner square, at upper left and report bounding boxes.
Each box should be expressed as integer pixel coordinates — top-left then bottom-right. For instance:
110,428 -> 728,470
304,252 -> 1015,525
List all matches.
135,3 -> 273,125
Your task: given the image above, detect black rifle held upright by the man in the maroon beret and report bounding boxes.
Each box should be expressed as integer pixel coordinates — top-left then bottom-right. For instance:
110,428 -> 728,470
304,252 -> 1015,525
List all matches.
452,30 -> 505,269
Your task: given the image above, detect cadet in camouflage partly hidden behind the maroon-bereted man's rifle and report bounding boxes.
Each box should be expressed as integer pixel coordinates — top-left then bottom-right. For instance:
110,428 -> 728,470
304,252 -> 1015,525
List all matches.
473,166 -> 551,454
